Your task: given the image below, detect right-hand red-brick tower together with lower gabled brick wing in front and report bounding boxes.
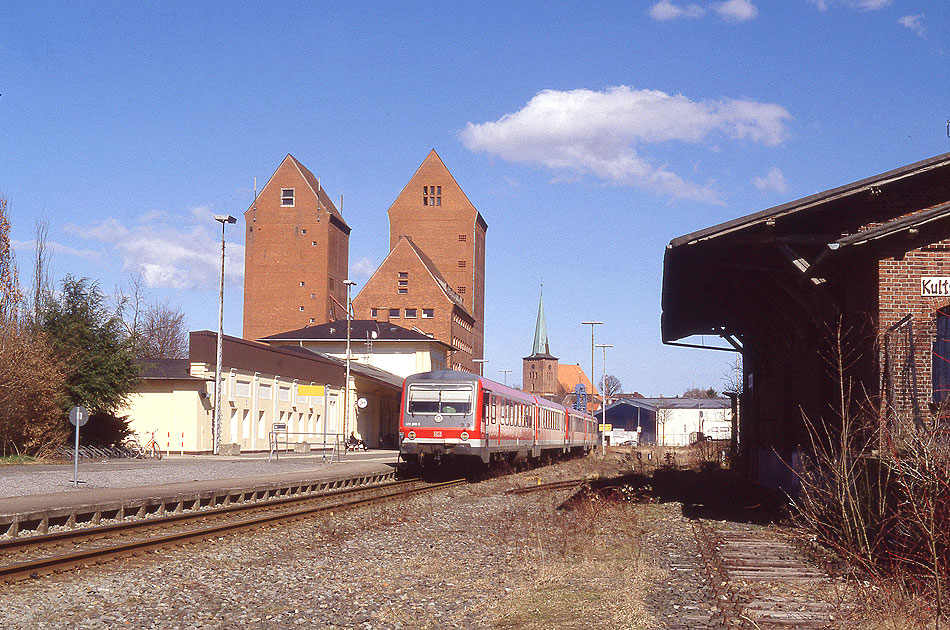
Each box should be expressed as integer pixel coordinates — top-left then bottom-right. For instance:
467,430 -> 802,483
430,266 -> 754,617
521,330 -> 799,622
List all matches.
353,149 -> 488,372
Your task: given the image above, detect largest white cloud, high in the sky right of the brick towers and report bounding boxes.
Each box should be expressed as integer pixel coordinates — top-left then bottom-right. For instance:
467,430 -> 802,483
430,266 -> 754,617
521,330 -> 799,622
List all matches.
460,86 -> 791,203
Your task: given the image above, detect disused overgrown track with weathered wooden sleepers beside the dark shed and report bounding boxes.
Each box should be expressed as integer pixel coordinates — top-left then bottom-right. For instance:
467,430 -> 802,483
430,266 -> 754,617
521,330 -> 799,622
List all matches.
691,519 -> 857,630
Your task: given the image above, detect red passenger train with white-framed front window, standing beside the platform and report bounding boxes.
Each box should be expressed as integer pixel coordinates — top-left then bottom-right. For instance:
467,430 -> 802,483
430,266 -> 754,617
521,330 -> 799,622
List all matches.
399,370 -> 598,466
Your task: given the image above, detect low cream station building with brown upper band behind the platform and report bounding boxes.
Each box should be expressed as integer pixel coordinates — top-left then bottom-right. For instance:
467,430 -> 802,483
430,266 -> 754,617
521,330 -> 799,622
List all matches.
119,331 -> 402,454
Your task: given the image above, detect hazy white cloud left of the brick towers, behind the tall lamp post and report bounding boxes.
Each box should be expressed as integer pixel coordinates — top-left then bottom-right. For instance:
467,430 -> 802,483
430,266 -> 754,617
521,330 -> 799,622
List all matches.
64,209 -> 244,289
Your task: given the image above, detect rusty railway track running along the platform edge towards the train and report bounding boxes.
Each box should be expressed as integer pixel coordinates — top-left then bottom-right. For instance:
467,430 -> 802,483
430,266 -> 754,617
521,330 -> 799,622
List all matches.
0,479 -> 465,582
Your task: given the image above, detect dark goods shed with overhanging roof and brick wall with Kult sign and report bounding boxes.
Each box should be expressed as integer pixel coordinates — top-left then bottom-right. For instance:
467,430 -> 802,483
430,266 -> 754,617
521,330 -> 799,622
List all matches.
662,154 -> 950,485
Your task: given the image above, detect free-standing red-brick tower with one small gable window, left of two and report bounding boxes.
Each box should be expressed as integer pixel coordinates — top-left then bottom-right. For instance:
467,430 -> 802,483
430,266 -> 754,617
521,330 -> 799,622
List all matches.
244,154 -> 350,340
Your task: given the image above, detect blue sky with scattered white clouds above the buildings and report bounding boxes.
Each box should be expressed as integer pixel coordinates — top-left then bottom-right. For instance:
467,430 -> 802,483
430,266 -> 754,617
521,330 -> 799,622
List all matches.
0,0 -> 950,395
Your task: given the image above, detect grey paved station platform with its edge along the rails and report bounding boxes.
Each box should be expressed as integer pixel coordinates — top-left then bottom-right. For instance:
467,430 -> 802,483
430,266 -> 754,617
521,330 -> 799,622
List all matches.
0,451 -> 397,536
